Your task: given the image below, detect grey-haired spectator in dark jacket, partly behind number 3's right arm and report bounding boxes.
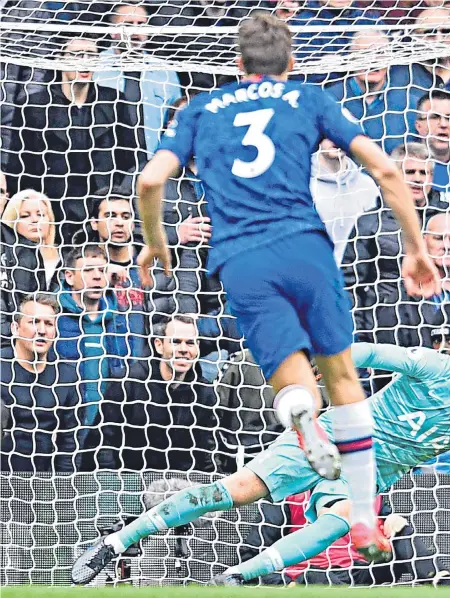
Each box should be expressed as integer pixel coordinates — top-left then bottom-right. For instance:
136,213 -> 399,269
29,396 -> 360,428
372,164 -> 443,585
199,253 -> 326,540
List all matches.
342,143 -> 448,342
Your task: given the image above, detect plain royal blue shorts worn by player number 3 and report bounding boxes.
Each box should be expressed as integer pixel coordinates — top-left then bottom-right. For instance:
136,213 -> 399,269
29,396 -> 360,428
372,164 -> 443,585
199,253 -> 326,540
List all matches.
221,232 -> 353,380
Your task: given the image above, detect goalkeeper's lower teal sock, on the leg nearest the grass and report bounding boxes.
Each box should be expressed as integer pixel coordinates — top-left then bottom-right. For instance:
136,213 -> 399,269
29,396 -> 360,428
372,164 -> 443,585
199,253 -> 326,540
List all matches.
226,513 -> 350,581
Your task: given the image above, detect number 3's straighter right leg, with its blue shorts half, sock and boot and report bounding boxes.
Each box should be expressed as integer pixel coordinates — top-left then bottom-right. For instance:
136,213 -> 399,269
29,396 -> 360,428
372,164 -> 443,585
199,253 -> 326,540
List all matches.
288,235 -> 389,560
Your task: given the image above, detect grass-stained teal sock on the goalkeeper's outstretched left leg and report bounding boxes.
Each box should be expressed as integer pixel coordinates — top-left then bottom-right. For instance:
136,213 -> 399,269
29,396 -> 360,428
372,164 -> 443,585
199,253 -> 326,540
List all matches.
105,482 -> 233,554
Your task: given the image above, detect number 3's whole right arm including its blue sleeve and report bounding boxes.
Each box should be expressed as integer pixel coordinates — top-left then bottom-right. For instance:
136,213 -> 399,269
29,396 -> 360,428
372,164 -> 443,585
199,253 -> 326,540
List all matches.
319,93 -> 441,297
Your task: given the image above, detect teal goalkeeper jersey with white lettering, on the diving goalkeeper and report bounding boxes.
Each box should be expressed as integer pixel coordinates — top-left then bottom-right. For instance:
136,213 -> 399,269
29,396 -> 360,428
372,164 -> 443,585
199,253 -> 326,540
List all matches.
320,343 -> 450,492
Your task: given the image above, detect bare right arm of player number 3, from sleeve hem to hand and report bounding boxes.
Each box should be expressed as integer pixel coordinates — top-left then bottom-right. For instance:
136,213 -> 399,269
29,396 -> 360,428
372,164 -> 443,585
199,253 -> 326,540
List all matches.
350,135 -> 441,297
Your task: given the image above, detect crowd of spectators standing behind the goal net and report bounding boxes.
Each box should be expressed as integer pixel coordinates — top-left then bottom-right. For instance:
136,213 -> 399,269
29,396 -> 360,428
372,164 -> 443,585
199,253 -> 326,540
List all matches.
0,0 -> 450,480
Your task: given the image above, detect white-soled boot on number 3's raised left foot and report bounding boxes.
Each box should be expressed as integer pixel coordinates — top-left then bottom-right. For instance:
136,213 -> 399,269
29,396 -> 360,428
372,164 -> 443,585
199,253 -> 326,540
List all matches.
292,409 -> 341,480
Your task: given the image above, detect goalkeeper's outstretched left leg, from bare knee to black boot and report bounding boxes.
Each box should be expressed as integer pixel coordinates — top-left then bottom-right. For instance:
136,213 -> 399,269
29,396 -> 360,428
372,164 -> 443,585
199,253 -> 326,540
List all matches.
72,468 -> 268,584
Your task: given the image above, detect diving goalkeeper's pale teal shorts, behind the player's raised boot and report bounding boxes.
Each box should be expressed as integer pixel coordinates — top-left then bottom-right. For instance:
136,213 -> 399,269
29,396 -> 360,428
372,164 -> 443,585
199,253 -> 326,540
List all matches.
246,430 -> 350,522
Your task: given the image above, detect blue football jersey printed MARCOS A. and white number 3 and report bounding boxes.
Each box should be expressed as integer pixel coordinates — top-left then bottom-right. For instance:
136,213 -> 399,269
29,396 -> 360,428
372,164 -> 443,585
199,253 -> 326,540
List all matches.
159,77 -> 363,273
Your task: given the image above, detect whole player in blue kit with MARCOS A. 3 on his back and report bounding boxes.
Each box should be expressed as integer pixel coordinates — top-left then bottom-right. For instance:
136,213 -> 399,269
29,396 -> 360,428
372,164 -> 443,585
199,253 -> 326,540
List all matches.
134,15 -> 440,558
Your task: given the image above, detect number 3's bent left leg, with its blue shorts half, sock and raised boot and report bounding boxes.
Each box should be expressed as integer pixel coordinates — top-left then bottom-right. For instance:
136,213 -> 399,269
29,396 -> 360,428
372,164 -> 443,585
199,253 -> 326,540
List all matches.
221,246 -> 340,486
